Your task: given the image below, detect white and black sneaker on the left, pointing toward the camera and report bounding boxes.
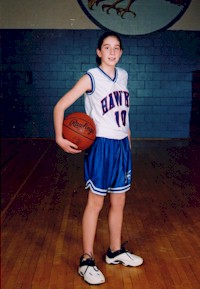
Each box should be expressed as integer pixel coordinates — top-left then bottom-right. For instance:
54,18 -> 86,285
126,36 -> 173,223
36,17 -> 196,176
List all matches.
78,256 -> 105,285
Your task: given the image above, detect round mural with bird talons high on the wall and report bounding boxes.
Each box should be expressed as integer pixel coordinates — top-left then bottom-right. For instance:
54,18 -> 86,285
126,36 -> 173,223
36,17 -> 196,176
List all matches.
77,0 -> 191,35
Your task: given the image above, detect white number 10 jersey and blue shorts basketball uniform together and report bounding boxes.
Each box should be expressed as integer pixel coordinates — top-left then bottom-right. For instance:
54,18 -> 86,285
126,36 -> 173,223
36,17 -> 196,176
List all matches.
84,68 -> 132,195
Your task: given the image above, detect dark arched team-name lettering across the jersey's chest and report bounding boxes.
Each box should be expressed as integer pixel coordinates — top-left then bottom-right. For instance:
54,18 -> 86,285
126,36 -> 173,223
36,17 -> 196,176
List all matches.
101,91 -> 129,114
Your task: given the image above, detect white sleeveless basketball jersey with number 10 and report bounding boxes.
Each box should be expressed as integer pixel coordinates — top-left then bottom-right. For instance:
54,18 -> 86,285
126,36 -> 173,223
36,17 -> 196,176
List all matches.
85,67 -> 130,139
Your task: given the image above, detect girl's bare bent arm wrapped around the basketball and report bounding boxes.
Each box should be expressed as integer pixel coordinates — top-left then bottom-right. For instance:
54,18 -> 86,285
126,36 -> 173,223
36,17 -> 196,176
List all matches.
54,74 -> 91,153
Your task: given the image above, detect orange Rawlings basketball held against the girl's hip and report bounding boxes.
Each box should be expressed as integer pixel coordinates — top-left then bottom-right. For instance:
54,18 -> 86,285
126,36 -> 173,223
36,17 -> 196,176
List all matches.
63,112 -> 96,150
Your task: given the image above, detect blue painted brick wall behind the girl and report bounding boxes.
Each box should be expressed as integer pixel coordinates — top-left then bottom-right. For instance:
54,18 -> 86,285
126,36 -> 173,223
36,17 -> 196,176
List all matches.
1,30 -> 200,138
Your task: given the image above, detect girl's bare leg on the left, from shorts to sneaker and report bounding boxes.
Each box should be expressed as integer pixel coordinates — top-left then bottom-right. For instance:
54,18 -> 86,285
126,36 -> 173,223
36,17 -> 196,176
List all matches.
82,191 -> 104,258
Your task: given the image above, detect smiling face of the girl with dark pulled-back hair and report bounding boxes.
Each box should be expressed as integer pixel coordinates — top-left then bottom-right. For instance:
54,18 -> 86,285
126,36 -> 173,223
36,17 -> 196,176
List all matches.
96,36 -> 122,66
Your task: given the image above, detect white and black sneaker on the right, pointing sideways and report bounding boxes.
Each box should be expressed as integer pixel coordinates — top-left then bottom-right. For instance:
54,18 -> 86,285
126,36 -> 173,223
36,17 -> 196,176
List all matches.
105,244 -> 143,267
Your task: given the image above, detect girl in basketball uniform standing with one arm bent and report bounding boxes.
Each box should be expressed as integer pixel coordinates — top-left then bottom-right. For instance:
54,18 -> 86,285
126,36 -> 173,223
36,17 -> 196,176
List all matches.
54,32 -> 143,284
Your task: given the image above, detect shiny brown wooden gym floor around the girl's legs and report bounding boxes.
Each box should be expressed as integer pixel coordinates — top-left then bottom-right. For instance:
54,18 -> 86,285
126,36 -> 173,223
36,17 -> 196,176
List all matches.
1,139 -> 200,289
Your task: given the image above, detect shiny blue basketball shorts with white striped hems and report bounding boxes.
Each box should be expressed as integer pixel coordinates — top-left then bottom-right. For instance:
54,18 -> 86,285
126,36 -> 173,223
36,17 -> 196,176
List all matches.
84,137 -> 132,196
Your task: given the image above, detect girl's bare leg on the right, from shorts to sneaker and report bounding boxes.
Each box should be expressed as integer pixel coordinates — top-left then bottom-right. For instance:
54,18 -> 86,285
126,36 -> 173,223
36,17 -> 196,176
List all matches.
108,193 -> 126,251
